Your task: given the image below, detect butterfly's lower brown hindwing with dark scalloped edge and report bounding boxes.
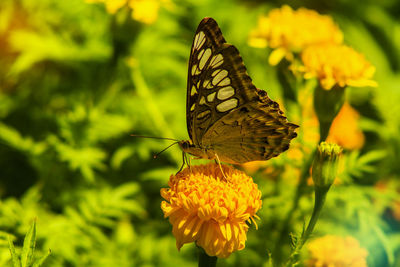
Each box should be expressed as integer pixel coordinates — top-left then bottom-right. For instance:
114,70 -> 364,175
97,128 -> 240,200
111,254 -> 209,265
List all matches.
202,92 -> 298,164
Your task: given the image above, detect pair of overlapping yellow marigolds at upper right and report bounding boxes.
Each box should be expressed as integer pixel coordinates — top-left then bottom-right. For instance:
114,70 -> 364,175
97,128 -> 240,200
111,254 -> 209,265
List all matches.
249,5 -> 377,90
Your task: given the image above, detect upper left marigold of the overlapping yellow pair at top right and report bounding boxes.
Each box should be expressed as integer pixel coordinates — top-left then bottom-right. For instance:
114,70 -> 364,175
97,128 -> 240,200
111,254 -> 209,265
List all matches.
249,5 -> 343,65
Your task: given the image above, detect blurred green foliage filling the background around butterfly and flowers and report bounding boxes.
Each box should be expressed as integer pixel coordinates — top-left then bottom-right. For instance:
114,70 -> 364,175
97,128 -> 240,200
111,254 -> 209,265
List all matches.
0,0 -> 400,266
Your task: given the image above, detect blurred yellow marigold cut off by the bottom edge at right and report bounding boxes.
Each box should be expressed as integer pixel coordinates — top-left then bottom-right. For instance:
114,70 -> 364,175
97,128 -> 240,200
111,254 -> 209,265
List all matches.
306,235 -> 368,267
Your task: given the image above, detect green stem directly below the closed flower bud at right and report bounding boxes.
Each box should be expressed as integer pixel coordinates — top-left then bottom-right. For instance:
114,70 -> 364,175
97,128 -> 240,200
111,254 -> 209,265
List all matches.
285,187 -> 329,267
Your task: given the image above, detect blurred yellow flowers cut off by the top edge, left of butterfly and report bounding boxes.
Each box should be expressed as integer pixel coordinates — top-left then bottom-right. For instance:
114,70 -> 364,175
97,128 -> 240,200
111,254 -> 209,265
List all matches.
85,0 -> 162,24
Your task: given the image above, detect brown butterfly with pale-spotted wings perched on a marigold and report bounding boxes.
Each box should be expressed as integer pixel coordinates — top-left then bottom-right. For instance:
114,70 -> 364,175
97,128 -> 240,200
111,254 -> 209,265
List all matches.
178,18 -> 298,164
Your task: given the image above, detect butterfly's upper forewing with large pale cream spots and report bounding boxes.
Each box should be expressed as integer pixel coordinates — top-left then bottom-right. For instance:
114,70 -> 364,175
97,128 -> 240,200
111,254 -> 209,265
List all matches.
186,18 -> 266,147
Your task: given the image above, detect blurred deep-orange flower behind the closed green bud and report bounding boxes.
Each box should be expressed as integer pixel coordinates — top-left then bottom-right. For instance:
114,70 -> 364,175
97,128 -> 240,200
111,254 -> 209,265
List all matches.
327,102 -> 365,150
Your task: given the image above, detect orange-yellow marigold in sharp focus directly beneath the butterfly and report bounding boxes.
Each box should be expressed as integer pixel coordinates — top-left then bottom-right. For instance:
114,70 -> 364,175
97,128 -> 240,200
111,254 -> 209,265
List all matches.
161,164 -> 261,258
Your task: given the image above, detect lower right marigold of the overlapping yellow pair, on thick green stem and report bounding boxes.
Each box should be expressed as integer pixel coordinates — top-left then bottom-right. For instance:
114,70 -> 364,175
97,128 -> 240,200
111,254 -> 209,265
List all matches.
300,44 -> 377,90
